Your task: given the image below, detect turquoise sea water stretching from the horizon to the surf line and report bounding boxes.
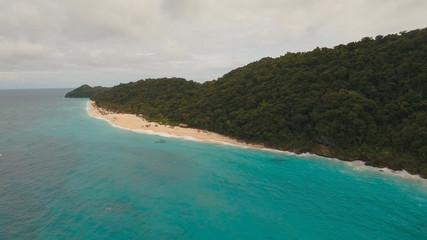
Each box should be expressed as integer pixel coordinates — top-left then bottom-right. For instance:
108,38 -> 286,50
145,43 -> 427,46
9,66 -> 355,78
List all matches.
0,89 -> 427,240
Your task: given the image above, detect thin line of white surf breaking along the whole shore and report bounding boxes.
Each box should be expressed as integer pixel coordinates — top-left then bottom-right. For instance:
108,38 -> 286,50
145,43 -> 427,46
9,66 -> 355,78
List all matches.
85,101 -> 427,186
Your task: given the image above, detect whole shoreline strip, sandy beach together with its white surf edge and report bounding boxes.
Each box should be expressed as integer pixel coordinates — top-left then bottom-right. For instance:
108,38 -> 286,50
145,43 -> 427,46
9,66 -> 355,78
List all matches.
86,100 -> 427,186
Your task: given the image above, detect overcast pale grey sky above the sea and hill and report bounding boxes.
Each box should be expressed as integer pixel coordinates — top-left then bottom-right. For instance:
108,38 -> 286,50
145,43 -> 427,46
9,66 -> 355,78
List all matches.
0,0 -> 427,89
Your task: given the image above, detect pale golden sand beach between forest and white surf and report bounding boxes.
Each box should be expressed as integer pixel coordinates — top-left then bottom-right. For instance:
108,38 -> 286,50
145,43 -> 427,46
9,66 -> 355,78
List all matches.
88,101 -> 264,148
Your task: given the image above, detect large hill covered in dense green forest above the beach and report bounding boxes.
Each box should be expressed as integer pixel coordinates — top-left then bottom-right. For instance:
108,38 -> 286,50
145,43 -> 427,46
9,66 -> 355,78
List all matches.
85,29 -> 427,177
